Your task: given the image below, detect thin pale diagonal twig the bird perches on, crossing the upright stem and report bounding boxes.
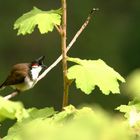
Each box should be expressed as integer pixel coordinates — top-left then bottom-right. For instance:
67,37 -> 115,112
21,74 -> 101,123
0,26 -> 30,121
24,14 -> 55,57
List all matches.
4,8 -> 99,99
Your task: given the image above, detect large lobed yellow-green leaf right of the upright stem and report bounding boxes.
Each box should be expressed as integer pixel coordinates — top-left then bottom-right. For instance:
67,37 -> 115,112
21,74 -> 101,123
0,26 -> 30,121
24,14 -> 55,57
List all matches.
67,58 -> 125,95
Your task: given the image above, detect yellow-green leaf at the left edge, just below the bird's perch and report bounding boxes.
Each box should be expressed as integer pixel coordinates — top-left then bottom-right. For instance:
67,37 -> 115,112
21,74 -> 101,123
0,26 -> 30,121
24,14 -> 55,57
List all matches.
0,97 -> 29,121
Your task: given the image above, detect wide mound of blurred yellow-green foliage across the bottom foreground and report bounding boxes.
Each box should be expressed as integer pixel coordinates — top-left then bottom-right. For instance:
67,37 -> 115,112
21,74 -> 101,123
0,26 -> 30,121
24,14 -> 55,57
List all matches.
3,105 -> 133,140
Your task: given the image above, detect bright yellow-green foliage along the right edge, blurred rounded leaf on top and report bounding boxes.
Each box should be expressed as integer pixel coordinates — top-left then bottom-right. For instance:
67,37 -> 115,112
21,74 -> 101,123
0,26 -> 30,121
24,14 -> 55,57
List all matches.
116,69 -> 140,139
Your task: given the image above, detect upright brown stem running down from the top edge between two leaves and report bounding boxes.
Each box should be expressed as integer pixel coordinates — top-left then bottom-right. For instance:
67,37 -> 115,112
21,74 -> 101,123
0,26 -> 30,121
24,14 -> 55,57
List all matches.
61,0 -> 69,107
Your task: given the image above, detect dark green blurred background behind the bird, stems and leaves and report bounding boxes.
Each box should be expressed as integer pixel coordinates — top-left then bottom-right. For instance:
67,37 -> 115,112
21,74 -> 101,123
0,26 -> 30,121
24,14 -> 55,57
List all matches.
0,0 -> 140,135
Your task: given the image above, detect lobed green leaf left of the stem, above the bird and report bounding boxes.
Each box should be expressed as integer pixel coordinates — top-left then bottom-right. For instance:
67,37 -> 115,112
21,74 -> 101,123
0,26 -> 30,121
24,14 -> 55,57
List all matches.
14,7 -> 61,35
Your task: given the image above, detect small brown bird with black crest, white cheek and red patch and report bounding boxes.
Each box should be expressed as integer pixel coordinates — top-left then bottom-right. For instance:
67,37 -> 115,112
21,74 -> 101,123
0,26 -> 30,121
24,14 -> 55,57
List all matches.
0,56 -> 47,92
